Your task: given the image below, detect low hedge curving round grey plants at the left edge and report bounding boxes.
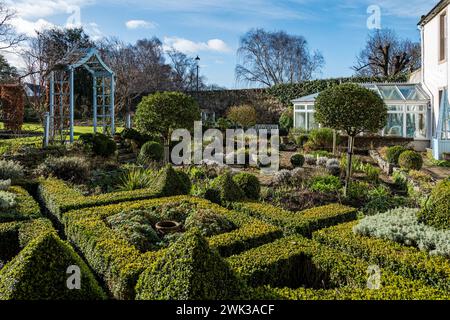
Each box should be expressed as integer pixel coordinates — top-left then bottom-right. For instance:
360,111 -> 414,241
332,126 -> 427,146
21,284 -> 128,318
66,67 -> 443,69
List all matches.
0,186 -> 41,223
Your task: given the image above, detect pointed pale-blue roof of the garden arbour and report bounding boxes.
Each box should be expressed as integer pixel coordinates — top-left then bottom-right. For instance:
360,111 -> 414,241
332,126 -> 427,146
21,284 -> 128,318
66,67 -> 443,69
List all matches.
52,48 -> 114,76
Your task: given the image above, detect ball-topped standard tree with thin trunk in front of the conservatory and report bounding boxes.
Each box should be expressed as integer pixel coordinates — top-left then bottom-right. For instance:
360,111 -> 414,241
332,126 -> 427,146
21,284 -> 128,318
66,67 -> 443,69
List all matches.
315,83 -> 387,195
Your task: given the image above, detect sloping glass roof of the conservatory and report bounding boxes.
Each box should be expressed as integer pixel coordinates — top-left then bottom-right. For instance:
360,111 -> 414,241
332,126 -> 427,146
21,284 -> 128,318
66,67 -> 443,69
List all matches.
292,83 -> 430,104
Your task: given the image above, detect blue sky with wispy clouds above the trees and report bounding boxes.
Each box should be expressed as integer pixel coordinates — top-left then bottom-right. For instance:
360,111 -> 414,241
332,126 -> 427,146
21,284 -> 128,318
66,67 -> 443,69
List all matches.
6,0 -> 437,88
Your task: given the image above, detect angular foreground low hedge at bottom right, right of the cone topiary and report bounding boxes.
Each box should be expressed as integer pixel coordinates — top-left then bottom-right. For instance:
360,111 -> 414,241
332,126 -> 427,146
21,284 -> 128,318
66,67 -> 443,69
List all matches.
227,236 -> 450,299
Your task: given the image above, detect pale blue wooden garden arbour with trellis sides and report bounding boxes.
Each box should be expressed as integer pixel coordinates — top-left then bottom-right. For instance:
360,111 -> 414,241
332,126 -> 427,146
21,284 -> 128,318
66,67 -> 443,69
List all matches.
48,48 -> 115,142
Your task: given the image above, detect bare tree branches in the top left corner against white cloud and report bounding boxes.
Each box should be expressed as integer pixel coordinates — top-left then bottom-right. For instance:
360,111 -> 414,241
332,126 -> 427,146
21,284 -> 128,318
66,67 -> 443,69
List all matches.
0,1 -> 26,50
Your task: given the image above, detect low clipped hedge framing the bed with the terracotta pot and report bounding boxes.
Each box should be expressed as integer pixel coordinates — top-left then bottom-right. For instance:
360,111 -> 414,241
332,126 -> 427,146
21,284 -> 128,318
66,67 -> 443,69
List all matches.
63,196 -> 282,299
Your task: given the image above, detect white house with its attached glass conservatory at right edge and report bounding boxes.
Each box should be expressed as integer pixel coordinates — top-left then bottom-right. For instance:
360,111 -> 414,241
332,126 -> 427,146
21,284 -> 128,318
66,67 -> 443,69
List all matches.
292,0 -> 450,159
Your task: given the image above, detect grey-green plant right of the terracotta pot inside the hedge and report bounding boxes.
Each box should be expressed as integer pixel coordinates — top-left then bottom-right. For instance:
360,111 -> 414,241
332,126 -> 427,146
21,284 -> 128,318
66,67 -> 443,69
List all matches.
184,210 -> 236,237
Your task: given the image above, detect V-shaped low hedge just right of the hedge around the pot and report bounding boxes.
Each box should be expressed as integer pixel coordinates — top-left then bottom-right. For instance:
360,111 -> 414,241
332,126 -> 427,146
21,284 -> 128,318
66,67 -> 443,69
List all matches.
233,202 -> 357,237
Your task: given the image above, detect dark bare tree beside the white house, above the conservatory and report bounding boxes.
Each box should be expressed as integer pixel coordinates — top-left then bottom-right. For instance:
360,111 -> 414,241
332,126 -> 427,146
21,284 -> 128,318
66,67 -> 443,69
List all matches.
353,29 -> 421,77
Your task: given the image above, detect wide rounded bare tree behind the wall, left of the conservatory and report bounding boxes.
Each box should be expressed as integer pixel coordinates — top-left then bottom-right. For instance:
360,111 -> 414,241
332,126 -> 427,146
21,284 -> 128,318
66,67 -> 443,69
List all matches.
236,29 -> 325,86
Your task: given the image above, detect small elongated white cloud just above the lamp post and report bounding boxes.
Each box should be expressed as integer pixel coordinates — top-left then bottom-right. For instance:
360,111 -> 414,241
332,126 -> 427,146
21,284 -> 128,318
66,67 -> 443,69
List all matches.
164,37 -> 231,53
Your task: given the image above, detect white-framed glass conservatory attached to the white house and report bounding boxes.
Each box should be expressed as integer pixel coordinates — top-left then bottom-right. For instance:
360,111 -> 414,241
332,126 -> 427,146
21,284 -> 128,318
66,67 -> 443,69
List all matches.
292,83 -> 432,140
